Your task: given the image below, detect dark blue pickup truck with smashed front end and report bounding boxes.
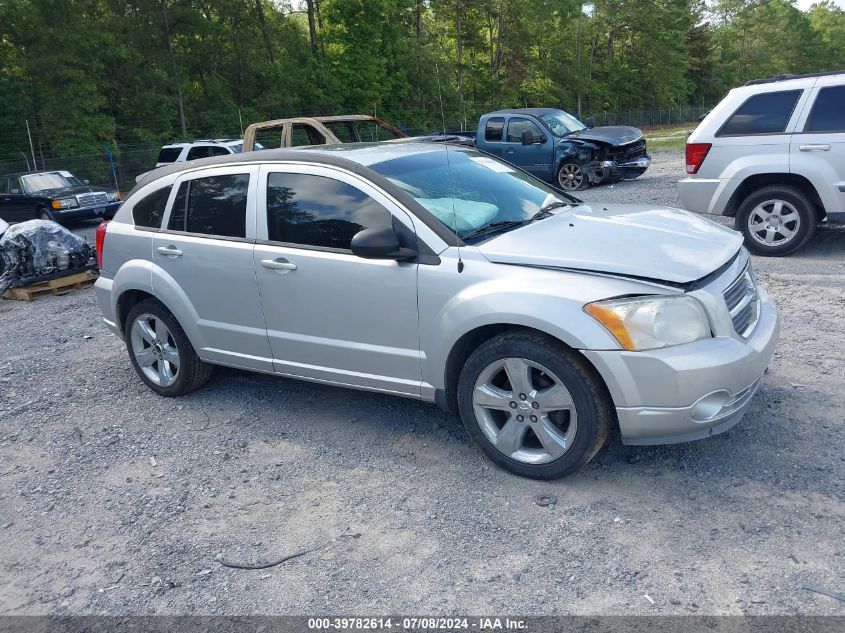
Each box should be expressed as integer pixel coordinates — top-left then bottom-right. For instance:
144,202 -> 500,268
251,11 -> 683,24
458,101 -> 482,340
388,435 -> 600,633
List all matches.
475,108 -> 651,191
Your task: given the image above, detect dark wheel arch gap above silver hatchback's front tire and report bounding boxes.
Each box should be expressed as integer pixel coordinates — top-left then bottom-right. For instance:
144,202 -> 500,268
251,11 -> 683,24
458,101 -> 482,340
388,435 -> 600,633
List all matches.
436,323 -> 613,414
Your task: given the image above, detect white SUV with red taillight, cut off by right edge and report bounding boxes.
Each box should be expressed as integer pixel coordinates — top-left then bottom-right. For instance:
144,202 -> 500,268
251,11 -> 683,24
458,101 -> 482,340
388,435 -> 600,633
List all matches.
678,71 -> 845,256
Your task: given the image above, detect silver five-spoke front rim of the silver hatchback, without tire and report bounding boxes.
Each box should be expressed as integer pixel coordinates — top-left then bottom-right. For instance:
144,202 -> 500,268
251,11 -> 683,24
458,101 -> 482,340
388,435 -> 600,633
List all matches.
472,358 -> 578,464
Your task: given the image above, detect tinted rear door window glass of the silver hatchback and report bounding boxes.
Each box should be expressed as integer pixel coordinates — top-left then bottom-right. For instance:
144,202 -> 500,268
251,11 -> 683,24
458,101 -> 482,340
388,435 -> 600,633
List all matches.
167,174 -> 249,237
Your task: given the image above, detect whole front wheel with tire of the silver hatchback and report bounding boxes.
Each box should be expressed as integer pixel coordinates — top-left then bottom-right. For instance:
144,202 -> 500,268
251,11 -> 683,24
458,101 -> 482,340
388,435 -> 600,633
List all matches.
458,332 -> 613,479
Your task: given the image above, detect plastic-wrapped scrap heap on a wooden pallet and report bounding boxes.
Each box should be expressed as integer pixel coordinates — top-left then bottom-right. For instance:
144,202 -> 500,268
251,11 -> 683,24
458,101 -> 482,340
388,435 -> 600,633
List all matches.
0,220 -> 97,295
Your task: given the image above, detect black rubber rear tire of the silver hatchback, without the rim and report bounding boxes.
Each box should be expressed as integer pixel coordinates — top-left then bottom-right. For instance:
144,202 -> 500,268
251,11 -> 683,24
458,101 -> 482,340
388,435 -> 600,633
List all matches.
123,299 -> 214,397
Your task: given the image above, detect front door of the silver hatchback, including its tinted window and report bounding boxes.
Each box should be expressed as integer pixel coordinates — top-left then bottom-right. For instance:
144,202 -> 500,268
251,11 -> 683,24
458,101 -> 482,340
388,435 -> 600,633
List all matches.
255,164 -> 421,396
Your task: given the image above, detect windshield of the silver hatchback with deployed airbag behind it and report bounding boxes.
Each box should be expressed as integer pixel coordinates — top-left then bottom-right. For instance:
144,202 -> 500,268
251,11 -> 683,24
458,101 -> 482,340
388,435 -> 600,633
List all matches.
370,146 -> 579,238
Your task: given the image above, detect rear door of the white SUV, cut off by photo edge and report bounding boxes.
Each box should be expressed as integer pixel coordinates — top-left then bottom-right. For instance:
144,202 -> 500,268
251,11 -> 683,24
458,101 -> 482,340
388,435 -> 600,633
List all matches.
790,75 -> 845,217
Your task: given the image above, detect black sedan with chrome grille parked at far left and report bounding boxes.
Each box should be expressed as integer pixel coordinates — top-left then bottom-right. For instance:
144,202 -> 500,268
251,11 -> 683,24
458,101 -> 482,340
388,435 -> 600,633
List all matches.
0,170 -> 121,222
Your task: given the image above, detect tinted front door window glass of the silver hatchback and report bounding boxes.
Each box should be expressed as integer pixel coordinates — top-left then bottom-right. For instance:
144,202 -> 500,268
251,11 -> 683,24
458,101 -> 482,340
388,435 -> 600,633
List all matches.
267,173 -> 392,250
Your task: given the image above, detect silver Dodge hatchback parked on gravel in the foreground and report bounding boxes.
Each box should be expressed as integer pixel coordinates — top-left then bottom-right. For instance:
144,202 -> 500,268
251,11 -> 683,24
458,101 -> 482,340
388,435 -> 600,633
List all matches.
96,142 -> 778,479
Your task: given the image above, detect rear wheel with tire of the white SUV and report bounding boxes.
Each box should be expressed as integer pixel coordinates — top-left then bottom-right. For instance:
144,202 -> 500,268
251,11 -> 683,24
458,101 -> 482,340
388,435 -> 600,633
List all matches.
736,185 -> 817,257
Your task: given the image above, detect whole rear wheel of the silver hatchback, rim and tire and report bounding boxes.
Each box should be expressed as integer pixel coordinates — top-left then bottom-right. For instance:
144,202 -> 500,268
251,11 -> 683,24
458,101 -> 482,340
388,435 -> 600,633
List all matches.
124,300 -> 213,396
